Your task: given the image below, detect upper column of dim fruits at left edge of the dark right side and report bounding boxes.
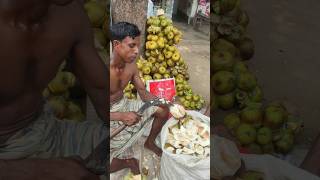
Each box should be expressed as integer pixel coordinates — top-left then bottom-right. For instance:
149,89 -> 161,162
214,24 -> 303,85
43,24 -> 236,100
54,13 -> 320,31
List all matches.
210,0 -> 263,110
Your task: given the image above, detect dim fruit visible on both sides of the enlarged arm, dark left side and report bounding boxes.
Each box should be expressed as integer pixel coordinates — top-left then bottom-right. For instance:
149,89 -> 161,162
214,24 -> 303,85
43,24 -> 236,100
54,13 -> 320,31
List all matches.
43,0 -> 109,122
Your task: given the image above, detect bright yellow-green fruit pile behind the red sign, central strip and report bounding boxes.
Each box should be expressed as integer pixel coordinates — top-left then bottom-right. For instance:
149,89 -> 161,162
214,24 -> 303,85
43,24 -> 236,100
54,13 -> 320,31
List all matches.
122,15 -> 204,110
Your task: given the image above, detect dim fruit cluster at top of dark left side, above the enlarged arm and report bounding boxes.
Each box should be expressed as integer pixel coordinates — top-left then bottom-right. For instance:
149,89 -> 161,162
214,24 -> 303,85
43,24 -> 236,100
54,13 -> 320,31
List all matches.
84,0 -> 110,63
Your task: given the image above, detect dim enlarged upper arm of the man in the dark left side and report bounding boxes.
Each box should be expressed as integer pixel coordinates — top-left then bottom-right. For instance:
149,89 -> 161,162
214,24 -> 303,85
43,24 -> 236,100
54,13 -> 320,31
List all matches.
72,1 -> 109,121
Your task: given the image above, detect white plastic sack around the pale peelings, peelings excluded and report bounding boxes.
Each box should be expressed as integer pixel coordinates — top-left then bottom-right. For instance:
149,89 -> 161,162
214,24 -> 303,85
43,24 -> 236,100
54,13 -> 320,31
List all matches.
160,111 -> 210,180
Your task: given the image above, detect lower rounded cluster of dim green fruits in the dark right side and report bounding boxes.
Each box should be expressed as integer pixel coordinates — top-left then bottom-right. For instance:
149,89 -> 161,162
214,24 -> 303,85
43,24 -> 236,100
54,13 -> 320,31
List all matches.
223,102 -> 302,155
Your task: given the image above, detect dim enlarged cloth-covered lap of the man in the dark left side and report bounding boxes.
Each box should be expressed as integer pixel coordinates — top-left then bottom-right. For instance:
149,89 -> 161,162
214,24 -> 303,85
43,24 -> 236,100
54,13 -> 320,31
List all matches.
0,104 -> 108,174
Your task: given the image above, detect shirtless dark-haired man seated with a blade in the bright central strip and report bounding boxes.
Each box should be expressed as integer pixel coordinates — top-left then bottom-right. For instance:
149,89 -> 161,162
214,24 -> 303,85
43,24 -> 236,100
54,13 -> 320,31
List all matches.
110,22 -> 169,174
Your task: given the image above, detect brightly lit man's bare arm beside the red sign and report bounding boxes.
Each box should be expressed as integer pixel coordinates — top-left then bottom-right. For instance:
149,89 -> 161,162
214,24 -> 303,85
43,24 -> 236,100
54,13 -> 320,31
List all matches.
133,65 -> 158,101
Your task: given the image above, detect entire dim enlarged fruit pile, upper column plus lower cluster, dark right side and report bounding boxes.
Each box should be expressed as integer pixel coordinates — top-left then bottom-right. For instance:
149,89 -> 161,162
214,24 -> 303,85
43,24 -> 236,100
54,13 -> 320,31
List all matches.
211,0 -> 301,154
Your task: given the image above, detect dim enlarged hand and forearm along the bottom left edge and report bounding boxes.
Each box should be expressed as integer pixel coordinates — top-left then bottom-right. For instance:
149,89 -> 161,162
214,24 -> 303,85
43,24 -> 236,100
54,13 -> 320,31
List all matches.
0,158 -> 99,180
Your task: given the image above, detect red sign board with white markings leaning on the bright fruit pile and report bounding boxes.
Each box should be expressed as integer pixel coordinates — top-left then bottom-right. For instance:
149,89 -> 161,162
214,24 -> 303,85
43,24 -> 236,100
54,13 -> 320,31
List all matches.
146,78 -> 176,101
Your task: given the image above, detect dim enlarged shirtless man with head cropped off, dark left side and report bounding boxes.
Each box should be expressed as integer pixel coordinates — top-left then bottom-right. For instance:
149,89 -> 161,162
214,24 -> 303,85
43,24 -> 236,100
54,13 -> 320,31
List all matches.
0,0 -> 109,180
